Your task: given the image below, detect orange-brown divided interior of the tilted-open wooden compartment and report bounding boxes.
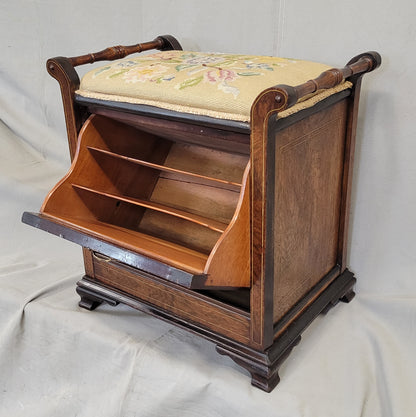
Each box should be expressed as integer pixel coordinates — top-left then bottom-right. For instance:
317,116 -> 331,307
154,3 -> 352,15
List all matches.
41,115 -> 249,282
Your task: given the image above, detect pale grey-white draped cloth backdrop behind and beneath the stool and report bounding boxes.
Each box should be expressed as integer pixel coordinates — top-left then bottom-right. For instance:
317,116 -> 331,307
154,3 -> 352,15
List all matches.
0,0 -> 416,417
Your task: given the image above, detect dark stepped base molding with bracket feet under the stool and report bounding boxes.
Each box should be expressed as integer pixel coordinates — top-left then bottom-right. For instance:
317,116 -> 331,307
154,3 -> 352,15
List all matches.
77,270 -> 356,392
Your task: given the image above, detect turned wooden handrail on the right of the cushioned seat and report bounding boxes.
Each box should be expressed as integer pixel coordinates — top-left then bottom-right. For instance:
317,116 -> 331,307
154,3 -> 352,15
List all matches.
273,51 -> 381,111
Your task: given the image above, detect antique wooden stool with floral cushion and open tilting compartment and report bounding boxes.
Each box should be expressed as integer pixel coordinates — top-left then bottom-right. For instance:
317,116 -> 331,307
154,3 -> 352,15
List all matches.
22,35 -> 381,391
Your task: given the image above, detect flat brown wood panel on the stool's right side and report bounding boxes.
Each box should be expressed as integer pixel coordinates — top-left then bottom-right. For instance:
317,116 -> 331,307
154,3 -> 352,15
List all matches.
273,100 -> 347,322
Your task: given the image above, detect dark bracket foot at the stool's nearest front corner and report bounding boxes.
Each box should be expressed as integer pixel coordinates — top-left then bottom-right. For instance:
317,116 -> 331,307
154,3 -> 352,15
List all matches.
216,336 -> 301,392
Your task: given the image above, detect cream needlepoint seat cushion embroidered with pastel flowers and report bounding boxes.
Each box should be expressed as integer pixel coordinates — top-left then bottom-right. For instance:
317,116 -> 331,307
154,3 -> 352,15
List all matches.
80,50 -> 342,121
